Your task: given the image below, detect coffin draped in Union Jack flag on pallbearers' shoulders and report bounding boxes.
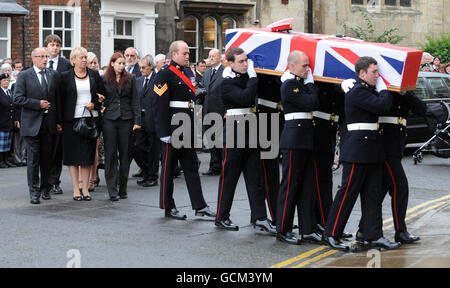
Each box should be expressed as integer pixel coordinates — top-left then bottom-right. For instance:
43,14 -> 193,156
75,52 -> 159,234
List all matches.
226,23 -> 422,91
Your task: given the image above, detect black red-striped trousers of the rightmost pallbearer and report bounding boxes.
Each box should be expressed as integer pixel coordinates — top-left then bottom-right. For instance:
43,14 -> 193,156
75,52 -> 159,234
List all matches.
359,158 -> 409,232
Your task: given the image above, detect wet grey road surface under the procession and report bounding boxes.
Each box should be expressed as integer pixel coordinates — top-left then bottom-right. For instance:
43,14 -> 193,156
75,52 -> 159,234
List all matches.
0,153 -> 450,268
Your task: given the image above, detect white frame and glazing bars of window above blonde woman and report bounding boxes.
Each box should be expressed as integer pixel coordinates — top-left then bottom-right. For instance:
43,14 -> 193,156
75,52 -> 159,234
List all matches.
39,5 -> 81,55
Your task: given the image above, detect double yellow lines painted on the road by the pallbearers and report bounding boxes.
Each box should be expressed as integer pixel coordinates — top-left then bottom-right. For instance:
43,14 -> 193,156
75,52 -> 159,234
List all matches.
270,194 -> 450,268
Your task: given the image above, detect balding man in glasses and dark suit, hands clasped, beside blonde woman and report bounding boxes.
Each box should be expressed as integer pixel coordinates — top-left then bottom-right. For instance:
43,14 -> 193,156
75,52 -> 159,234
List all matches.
14,48 -> 61,204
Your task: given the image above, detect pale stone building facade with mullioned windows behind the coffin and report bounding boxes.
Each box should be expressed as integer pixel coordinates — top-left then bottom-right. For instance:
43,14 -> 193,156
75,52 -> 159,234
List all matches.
156,0 -> 450,62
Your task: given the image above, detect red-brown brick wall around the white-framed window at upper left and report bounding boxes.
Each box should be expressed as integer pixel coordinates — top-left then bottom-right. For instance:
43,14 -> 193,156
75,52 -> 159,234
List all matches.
11,0 -> 101,65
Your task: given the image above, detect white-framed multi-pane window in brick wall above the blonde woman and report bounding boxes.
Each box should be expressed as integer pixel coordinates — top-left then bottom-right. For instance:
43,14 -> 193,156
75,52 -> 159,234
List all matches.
39,6 -> 81,59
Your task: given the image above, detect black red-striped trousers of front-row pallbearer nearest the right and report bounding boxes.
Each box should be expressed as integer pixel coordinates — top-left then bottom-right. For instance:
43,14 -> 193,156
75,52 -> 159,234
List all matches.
325,162 -> 383,240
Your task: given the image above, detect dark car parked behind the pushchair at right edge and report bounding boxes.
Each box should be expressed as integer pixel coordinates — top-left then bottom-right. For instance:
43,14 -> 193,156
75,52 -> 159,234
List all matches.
407,72 -> 450,146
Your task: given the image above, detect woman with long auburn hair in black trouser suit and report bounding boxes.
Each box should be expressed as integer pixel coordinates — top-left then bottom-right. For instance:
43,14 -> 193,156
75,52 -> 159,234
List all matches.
102,52 -> 141,201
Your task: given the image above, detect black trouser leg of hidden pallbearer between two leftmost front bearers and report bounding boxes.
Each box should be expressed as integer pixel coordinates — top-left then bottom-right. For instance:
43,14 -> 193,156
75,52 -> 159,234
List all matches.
261,157 -> 280,225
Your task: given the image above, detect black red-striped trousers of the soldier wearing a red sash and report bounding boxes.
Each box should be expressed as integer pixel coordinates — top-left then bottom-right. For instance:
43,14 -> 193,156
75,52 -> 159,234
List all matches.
159,143 -> 207,211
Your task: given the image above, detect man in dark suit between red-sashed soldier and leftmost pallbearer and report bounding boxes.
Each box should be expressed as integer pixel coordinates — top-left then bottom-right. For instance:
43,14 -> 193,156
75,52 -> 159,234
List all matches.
201,49 -> 225,175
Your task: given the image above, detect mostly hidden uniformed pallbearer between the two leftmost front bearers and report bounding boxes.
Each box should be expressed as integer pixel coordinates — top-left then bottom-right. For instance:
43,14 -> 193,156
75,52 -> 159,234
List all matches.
257,74 -> 284,225
